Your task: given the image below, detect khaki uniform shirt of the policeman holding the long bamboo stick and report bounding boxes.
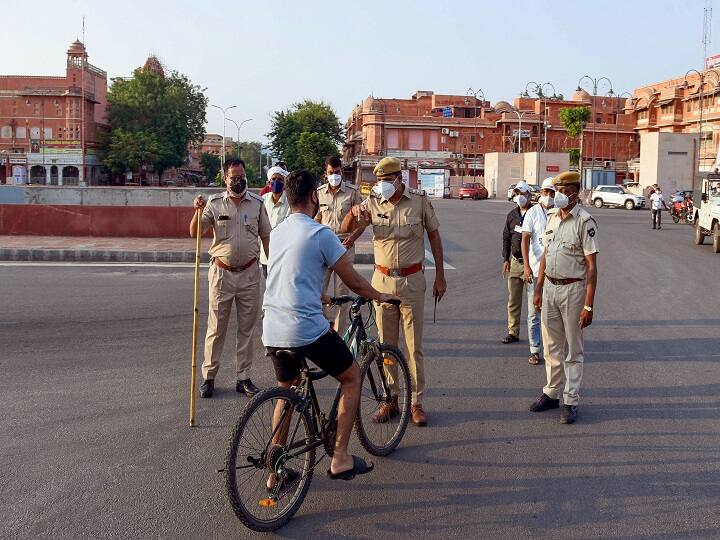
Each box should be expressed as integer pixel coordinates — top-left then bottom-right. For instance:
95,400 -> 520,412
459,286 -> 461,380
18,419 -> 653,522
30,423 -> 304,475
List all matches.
201,191 -> 270,267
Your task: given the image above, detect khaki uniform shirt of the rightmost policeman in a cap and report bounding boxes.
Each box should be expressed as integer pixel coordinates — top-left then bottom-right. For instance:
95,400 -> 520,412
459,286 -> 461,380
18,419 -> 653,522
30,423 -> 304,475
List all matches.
544,205 -> 598,279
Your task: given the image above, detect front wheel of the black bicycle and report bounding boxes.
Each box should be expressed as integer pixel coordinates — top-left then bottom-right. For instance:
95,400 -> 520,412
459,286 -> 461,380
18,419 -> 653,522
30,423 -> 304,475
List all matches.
355,344 -> 411,456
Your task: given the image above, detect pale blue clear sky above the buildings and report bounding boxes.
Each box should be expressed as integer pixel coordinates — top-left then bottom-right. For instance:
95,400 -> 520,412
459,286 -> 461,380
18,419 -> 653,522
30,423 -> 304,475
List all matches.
0,0 -> 720,141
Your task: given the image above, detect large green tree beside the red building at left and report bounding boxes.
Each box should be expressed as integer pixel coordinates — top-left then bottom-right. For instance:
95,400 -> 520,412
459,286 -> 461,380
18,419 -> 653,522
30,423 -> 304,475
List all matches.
102,69 -> 208,177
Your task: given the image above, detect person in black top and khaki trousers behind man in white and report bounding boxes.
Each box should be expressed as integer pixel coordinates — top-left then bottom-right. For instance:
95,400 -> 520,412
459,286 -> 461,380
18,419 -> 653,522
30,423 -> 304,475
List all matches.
501,180 -> 531,344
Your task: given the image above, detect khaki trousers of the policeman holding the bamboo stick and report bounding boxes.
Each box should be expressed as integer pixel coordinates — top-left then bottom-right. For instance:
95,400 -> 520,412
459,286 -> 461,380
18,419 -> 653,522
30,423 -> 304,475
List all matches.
202,264 -> 260,380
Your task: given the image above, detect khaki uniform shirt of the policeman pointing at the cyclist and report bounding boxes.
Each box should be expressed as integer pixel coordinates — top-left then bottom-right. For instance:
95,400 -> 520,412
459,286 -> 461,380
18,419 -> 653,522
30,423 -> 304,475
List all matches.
363,186 -> 440,269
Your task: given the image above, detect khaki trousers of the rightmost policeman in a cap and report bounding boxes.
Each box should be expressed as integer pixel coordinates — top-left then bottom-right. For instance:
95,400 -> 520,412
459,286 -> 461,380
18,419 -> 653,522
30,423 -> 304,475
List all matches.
540,280 -> 585,405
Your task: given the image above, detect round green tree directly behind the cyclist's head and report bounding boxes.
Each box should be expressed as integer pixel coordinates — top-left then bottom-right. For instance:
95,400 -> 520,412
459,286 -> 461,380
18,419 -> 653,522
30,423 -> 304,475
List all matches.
268,100 -> 343,173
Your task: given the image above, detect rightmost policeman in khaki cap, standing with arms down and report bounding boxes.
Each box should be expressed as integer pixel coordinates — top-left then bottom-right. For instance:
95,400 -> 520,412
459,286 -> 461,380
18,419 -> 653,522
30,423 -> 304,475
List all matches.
530,172 -> 598,424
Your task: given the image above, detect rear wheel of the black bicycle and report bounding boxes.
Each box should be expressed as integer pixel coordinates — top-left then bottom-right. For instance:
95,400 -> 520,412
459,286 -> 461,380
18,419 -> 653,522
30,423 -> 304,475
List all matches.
225,388 -> 315,532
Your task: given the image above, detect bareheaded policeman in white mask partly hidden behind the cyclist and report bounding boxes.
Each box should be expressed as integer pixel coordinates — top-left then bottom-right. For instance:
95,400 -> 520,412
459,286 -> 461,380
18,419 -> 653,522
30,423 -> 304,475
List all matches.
315,156 -> 362,336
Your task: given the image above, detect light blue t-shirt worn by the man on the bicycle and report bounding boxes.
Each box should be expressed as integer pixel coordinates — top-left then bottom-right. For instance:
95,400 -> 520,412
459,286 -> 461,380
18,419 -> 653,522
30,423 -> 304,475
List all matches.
262,214 -> 345,347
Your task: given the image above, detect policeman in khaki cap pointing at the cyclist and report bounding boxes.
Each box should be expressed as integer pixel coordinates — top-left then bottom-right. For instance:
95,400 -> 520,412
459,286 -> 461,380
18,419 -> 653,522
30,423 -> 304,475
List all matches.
341,157 -> 447,426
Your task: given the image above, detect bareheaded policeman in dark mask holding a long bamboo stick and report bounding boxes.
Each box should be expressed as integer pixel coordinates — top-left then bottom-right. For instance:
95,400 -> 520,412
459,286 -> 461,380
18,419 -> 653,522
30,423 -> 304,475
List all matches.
190,159 -> 270,398
